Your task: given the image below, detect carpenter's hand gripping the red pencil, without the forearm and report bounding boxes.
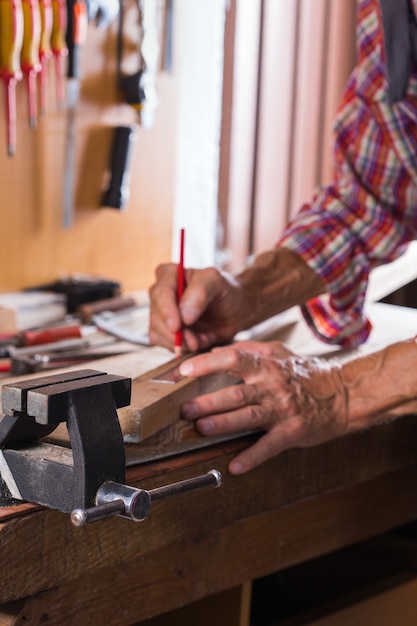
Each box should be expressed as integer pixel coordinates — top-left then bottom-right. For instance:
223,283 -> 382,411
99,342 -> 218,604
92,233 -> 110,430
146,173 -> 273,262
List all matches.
149,263 -> 250,352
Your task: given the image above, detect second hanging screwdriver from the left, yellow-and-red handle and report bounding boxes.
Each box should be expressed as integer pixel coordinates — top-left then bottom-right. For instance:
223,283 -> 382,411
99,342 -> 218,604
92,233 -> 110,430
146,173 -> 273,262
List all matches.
21,0 -> 42,128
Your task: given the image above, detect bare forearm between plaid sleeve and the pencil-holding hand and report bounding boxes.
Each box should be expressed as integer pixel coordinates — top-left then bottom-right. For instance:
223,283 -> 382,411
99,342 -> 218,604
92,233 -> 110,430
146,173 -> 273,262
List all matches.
236,248 -> 325,328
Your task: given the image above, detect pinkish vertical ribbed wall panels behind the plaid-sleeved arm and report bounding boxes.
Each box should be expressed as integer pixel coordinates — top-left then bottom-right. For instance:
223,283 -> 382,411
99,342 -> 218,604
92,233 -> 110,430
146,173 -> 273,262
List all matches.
219,0 -> 356,269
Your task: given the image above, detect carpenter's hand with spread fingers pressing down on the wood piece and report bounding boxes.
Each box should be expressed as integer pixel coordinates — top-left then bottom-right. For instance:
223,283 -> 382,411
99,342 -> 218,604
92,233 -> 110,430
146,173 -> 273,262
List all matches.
180,341 -> 348,474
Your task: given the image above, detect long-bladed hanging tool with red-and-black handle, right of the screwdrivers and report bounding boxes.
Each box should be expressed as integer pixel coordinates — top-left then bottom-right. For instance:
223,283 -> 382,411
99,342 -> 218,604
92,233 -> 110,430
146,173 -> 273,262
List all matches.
62,0 -> 88,228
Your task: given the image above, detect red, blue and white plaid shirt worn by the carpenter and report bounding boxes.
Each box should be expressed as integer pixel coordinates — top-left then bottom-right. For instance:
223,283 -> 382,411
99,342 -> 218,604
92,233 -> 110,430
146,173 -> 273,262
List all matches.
278,0 -> 417,347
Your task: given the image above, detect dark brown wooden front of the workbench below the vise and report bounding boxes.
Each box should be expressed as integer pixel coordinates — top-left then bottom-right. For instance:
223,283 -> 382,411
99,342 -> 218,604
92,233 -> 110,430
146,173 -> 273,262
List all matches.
0,300 -> 417,626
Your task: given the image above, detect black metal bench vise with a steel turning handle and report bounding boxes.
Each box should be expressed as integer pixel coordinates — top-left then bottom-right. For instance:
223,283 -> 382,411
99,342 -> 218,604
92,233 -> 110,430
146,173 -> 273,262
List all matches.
0,370 -> 221,526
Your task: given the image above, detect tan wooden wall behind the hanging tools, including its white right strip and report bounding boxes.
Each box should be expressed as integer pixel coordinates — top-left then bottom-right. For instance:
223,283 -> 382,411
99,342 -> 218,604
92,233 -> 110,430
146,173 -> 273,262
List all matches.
0,0 -> 176,291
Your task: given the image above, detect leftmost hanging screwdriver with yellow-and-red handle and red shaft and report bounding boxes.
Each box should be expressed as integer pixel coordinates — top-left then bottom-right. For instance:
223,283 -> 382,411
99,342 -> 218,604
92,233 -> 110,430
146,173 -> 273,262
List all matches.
0,0 -> 23,156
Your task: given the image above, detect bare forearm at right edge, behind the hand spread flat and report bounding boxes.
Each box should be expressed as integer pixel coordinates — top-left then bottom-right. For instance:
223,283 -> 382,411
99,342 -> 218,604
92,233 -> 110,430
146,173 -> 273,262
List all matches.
340,339 -> 417,430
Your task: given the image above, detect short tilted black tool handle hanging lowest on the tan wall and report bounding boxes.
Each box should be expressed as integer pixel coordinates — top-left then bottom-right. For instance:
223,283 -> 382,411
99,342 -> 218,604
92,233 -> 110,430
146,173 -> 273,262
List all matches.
101,126 -> 135,210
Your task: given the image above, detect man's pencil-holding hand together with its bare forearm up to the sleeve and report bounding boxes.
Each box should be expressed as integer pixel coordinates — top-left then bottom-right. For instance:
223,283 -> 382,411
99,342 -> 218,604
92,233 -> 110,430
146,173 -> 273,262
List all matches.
149,248 -> 324,352
